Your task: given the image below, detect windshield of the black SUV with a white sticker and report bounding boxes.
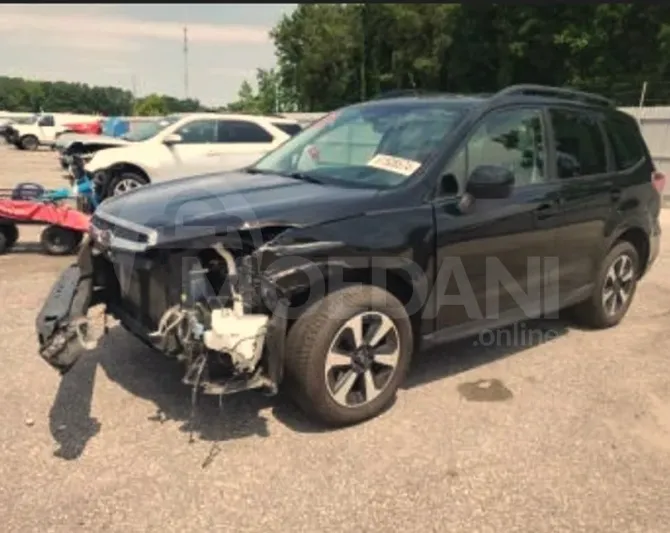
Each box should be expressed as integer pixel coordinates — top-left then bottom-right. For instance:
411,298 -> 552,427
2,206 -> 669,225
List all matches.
250,101 -> 464,188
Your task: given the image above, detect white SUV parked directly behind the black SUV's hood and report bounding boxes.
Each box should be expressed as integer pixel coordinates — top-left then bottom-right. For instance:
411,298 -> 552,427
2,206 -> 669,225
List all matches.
84,113 -> 301,199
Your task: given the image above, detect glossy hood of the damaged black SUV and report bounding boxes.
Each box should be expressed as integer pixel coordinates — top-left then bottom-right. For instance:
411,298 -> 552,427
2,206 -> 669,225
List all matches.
93,172 -> 378,244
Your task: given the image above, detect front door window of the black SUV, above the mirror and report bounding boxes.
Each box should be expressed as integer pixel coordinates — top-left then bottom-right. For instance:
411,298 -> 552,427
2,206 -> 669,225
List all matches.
441,108 -> 547,196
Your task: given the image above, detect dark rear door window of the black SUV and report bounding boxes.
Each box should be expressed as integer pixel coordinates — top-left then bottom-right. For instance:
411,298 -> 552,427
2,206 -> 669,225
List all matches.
550,109 -> 607,179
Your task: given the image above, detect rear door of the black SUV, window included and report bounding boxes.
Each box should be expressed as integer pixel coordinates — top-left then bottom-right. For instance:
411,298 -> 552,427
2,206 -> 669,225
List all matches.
549,106 -> 619,300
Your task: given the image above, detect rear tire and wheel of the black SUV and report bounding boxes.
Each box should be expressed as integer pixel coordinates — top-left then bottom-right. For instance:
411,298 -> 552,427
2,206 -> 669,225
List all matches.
570,241 -> 640,329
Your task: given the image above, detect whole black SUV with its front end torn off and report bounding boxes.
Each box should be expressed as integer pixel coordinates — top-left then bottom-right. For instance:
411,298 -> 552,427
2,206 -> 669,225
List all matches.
37,85 -> 665,424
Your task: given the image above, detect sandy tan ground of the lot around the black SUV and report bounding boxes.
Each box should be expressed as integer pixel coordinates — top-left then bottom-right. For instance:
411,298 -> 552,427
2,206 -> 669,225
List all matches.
0,142 -> 670,533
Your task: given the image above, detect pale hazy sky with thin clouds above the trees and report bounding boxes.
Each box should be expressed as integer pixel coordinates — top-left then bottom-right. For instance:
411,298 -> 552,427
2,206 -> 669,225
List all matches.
0,4 -> 295,105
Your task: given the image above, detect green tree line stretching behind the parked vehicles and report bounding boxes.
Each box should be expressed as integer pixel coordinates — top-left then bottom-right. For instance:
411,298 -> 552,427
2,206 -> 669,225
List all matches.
0,3 -> 670,115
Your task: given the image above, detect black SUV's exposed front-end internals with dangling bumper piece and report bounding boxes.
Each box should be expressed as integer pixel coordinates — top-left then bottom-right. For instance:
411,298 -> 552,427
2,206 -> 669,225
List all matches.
36,235 -> 288,402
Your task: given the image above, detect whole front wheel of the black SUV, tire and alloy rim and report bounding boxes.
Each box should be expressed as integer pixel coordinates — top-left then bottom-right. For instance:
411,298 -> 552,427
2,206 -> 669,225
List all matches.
286,286 -> 413,425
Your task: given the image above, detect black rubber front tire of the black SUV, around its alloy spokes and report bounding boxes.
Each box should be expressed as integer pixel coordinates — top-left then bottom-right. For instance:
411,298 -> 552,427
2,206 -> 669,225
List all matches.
285,285 -> 414,426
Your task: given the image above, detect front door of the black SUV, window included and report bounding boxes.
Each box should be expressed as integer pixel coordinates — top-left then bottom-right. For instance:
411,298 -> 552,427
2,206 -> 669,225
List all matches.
432,107 -> 559,336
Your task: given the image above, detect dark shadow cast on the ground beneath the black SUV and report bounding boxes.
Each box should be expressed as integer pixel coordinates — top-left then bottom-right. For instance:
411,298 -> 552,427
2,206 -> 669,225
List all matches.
49,320 -> 568,462
